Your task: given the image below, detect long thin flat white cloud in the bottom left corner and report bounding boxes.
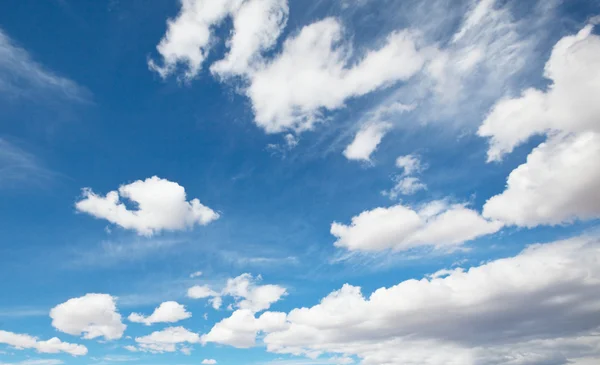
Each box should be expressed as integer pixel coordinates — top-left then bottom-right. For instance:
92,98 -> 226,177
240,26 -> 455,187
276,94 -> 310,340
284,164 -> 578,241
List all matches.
0,330 -> 87,356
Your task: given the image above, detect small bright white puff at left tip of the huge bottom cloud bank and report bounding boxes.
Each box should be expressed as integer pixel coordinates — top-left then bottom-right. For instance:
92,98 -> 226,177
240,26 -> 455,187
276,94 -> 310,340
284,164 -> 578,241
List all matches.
202,309 -> 285,348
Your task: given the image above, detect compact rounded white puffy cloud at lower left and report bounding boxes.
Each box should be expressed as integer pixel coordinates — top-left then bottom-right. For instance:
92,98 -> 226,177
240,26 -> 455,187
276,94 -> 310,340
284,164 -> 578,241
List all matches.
50,294 -> 127,340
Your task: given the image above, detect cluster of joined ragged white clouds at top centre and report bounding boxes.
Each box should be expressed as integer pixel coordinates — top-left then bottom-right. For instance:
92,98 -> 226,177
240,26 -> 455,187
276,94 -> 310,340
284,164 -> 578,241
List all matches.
150,0 -> 427,134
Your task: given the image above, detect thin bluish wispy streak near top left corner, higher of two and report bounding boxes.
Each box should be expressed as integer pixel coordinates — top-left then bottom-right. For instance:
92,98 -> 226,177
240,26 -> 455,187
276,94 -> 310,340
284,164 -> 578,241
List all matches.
0,29 -> 90,102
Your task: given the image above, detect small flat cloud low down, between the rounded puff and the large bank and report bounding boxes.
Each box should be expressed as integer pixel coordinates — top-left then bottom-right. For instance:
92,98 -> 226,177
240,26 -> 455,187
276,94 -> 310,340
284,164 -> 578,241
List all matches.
135,327 -> 200,353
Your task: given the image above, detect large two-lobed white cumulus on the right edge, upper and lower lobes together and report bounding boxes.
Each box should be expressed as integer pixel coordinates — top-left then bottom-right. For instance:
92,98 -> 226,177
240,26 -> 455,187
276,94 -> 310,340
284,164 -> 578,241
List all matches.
478,25 -> 600,227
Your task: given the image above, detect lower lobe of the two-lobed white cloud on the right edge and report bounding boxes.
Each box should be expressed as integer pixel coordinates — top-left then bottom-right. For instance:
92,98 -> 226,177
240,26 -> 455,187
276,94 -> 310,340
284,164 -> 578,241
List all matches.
483,132 -> 600,227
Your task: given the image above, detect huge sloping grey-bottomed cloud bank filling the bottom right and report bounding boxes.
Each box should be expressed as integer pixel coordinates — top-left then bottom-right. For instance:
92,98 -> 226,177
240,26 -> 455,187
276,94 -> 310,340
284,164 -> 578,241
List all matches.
213,237 -> 600,365
